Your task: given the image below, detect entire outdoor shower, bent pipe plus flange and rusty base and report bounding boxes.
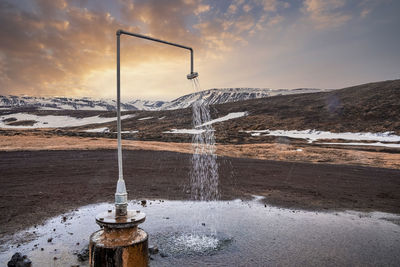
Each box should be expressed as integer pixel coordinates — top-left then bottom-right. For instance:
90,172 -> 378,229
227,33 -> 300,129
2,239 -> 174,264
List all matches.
89,30 -> 198,266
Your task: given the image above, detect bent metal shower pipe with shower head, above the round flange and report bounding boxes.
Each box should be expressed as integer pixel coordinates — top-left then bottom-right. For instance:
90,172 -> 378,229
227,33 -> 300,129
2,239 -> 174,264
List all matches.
115,30 -> 198,216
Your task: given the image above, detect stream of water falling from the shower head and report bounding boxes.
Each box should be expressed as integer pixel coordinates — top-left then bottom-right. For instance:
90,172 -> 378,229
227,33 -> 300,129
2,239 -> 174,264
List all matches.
190,78 -> 219,201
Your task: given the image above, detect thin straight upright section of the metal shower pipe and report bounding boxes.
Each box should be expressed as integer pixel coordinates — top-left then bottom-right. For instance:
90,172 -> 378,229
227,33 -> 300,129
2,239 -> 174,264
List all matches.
117,32 -> 124,180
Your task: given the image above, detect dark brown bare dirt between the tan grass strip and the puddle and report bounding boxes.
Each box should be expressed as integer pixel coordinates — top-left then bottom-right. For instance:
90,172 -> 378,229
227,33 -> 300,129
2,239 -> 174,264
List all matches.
0,149 -> 400,240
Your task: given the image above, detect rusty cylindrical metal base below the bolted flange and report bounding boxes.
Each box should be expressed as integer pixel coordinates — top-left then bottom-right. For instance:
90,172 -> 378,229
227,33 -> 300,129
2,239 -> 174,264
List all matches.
89,226 -> 149,267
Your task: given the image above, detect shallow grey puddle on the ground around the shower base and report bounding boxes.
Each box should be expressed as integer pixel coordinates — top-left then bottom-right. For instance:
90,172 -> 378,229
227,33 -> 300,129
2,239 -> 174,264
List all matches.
0,198 -> 400,266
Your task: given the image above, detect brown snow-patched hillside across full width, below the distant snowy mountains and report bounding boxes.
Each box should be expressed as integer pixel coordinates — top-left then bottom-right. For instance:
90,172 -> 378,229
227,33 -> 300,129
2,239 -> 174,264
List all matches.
0,80 -> 400,146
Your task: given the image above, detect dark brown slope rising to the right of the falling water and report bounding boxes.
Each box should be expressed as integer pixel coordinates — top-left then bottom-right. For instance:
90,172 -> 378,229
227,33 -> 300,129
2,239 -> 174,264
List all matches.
212,80 -> 400,138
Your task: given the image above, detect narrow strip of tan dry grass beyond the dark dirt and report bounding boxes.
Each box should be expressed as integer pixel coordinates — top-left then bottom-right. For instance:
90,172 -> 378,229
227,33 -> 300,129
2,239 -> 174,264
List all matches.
0,136 -> 400,169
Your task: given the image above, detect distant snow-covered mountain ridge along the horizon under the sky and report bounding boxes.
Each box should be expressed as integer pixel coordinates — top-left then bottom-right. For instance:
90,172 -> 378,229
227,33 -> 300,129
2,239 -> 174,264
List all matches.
0,88 -> 324,110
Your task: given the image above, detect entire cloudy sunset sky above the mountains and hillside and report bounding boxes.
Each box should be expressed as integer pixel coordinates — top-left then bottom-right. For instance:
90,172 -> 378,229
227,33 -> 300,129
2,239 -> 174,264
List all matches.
0,0 -> 400,100
